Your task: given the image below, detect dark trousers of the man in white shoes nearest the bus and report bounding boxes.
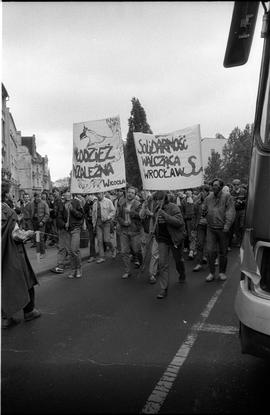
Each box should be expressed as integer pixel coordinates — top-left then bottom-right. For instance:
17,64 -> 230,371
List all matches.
206,226 -> 228,274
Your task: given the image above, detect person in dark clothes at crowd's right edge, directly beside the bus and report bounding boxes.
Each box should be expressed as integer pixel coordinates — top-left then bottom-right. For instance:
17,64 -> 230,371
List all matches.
230,179 -> 247,247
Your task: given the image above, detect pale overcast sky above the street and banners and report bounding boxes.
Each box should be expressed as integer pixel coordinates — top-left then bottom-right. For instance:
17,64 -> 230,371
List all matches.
2,1 -> 263,181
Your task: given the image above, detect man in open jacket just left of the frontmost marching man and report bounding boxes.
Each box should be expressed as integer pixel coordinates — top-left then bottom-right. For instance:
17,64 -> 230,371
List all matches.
116,186 -> 142,279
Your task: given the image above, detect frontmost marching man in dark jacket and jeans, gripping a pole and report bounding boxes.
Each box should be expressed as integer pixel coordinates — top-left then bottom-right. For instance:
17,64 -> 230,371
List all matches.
153,190 -> 186,299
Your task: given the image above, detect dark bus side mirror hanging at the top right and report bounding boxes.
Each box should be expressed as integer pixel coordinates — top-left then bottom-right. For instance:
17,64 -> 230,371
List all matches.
223,1 -> 260,68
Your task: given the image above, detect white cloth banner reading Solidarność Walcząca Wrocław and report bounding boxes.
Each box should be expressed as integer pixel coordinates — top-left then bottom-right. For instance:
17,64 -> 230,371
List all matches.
133,124 -> 203,190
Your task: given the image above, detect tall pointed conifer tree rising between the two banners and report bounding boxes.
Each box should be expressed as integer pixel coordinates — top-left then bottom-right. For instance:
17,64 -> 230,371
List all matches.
124,97 -> 153,188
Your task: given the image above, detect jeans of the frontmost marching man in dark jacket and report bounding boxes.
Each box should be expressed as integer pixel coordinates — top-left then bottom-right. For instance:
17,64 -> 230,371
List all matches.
158,242 -> 186,290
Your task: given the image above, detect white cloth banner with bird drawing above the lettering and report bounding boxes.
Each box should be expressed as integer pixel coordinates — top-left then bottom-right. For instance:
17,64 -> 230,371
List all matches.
71,116 -> 126,193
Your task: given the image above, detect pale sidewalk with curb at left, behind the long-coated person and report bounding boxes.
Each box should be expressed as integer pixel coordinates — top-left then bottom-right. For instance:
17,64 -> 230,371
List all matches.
25,242 -> 89,276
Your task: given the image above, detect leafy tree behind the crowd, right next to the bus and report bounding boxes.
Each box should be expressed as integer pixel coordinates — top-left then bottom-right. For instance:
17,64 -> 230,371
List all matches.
222,124 -> 253,183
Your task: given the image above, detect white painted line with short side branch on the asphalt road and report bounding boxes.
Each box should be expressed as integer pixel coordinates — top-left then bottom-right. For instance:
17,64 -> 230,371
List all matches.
142,281 -> 226,414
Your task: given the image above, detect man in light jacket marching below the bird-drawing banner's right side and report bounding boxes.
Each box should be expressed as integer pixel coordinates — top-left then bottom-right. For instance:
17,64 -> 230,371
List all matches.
92,192 -> 115,264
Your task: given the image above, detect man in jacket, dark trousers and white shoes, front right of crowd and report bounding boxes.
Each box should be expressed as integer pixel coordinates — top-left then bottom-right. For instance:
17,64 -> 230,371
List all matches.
202,179 -> 235,282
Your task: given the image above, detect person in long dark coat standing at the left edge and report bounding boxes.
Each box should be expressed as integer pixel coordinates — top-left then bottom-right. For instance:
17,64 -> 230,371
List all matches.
1,183 -> 41,328
